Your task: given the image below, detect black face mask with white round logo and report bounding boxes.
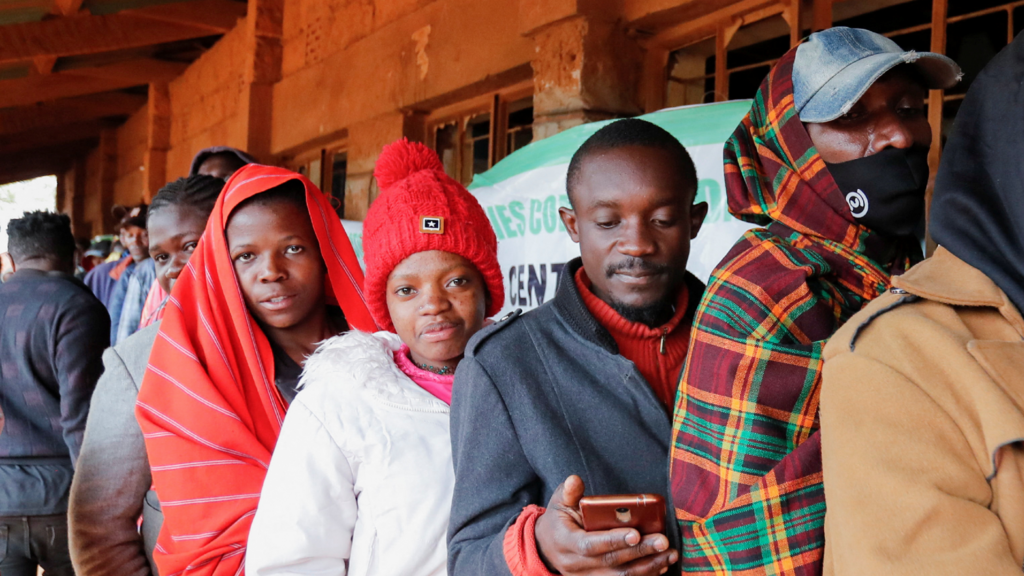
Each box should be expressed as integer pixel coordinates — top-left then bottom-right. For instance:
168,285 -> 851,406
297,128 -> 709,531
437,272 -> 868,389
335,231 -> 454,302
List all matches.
825,148 -> 928,237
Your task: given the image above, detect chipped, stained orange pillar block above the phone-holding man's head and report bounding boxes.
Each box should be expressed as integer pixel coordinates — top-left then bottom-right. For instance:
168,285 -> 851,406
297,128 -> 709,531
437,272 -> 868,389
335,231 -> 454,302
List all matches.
525,13 -> 643,140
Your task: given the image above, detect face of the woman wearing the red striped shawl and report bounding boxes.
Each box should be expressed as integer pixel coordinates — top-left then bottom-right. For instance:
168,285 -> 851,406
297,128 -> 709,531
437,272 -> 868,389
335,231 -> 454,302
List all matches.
225,201 -> 327,330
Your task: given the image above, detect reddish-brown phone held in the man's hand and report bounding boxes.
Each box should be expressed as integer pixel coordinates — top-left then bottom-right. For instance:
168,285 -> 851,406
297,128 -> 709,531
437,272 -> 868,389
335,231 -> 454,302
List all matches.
580,494 -> 665,534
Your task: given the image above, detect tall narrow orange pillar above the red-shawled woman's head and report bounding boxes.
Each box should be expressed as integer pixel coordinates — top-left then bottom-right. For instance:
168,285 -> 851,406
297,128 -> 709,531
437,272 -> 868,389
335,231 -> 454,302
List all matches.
240,0 -> 285,162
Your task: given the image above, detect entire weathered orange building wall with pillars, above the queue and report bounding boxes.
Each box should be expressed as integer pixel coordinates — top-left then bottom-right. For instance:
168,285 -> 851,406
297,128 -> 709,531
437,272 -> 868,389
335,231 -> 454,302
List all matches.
70,0 -> 712,232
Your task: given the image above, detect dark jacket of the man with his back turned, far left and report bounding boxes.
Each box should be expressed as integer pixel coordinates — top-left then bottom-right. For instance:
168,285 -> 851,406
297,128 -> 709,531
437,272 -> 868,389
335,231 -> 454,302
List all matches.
0,269 -> 111,516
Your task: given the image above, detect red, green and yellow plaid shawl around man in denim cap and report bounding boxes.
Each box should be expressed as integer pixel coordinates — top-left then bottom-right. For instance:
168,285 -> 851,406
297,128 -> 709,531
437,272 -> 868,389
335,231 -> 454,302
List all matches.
671,50 -> 921,575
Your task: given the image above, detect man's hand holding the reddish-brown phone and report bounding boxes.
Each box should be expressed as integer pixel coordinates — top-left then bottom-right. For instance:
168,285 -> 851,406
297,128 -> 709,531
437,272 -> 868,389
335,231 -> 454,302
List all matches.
534,476 -> 679,576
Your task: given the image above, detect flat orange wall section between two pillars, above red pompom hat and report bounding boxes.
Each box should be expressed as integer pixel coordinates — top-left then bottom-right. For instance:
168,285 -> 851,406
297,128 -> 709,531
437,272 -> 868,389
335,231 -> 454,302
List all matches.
271,0 -> 534,154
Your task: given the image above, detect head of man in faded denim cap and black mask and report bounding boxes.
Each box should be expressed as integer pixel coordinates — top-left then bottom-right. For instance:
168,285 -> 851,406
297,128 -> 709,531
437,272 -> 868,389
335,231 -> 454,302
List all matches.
793,27 -> 962,238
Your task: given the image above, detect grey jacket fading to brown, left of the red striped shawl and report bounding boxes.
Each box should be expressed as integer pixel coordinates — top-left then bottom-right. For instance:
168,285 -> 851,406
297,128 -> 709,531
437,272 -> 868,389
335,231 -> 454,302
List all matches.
68,323 -> 164,576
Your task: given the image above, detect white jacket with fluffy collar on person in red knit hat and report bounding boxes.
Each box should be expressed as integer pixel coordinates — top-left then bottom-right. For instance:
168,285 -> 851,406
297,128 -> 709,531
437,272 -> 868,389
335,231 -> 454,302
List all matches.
246,331 -> 455,576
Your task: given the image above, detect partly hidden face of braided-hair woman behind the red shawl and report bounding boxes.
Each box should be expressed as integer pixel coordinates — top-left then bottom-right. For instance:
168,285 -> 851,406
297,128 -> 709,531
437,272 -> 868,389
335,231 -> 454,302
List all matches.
146,205 -> 206,294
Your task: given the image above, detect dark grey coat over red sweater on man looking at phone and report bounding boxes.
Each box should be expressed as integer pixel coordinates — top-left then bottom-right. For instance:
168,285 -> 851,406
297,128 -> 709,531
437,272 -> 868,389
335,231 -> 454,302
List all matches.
449,258 -> 703,576
